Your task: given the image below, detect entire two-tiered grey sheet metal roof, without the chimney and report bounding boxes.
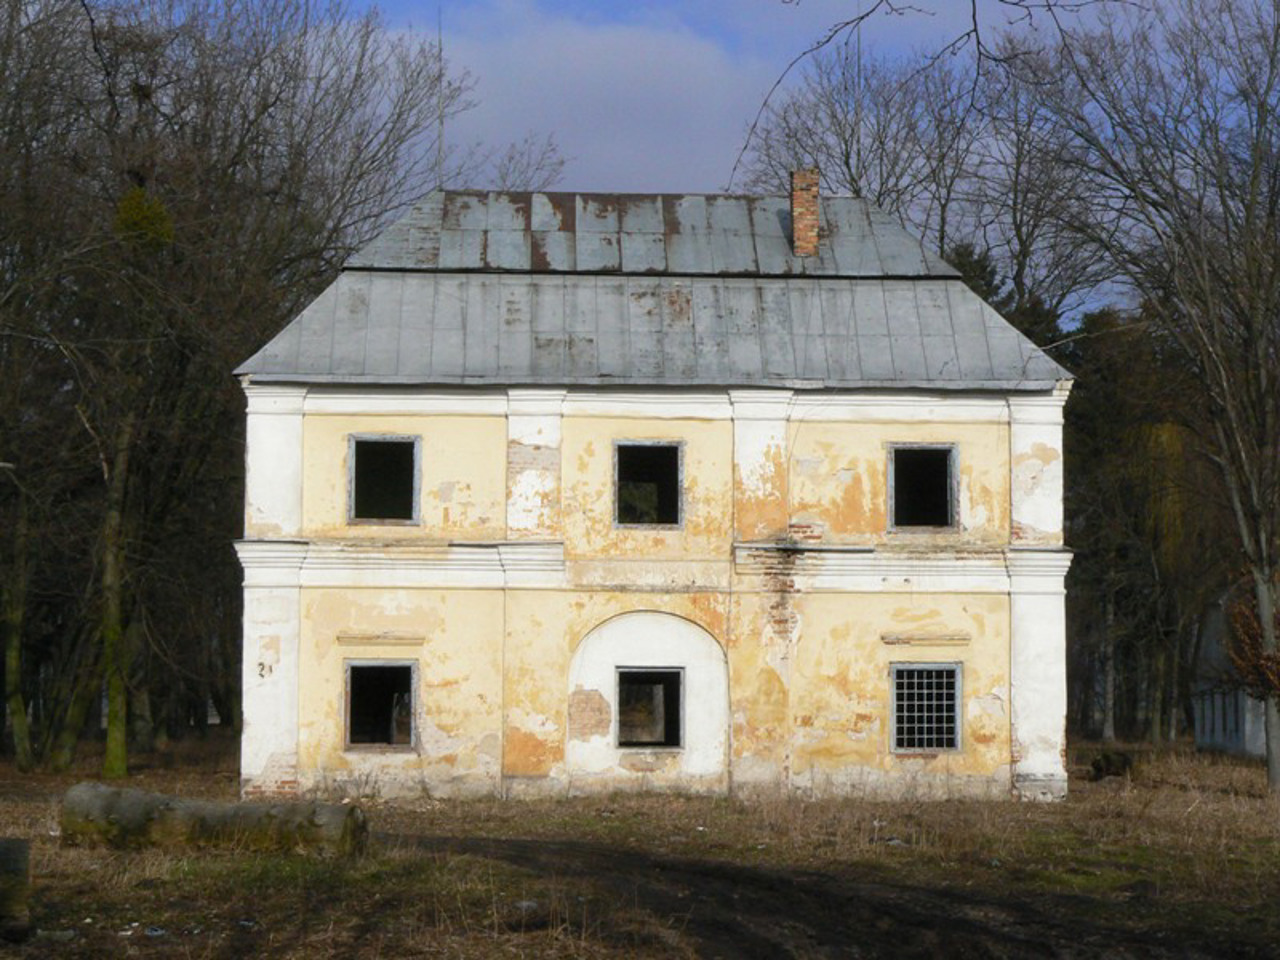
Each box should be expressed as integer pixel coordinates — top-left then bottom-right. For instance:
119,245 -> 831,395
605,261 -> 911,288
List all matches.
237,192 -> 1070,390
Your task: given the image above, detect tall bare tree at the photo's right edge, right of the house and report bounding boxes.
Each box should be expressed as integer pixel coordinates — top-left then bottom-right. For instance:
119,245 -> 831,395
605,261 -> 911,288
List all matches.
1038,0 -> 1280,791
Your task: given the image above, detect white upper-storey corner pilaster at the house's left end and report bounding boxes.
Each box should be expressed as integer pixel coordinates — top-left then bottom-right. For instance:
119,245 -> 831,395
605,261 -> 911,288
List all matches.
243,378 -> 307,539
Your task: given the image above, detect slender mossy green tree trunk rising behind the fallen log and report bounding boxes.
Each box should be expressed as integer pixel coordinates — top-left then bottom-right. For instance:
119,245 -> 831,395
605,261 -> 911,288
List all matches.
102,413 -> 133,780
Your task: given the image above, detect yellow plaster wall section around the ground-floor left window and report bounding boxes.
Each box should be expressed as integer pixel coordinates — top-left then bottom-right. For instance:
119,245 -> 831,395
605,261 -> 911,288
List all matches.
298,589 -> 503,780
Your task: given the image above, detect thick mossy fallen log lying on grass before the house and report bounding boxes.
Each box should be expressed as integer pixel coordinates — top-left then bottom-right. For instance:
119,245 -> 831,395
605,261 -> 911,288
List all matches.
61,782 -> 369,855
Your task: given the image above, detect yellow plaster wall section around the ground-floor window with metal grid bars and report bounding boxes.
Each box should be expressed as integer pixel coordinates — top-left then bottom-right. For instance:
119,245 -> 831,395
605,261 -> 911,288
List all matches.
728,593 -> 1010,782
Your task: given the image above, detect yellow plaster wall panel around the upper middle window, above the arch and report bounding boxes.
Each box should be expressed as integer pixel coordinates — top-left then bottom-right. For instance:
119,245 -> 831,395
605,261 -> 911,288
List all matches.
561,417 -> 733,559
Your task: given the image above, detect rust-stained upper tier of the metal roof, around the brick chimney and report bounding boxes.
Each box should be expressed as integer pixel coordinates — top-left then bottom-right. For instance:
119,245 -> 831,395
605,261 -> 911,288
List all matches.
347,191 -> 959,276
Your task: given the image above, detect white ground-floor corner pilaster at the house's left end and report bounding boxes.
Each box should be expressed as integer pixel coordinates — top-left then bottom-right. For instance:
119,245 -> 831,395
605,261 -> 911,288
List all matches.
236,540 -> 307,794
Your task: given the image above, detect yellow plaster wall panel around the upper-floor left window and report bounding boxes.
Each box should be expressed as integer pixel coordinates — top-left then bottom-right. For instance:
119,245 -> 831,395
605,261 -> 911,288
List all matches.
302,413 -> 507,540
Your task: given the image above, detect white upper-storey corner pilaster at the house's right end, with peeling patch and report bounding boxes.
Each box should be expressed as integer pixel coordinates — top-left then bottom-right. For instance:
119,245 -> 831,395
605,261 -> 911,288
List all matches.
1009,383 -> 1071,547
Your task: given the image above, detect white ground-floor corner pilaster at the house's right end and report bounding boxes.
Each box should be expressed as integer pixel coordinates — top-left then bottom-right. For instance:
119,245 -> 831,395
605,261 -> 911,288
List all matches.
1007,549 -> 1071,800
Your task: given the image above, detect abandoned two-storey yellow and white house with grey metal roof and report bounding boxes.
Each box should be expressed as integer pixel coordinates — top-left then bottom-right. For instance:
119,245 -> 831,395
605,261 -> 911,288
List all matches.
237,172 -> 1070,799
